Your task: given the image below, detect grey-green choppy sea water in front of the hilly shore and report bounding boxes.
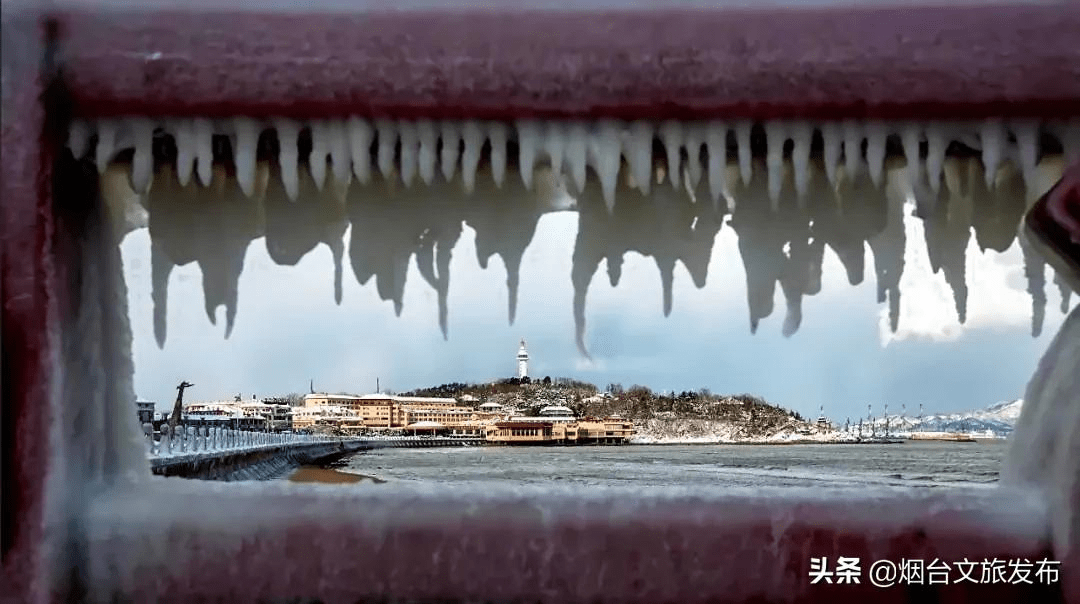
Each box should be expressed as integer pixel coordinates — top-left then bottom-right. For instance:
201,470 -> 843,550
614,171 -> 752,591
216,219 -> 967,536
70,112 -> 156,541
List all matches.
333,441 -> 1008,488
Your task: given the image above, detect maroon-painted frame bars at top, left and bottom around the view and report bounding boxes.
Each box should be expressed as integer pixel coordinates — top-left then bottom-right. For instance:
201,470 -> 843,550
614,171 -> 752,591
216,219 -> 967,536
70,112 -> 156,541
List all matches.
0,4 -> 1080,603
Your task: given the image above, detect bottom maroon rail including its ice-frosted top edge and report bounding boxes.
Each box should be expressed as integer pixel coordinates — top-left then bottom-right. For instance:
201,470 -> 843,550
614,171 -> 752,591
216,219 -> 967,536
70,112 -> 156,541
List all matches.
84,479 -> 1054,603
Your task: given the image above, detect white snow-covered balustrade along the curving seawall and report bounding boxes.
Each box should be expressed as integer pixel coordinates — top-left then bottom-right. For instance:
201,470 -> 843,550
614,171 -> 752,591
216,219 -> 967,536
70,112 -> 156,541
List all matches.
143,424 -> 341,457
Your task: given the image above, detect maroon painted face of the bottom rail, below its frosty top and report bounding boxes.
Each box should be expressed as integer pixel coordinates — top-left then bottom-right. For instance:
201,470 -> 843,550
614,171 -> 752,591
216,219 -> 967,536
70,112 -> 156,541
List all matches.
86,497 -> 1062,604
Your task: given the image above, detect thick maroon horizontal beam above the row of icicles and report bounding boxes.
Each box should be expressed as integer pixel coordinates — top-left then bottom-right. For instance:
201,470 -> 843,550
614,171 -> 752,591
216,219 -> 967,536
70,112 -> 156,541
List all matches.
56,3 -> 1080,119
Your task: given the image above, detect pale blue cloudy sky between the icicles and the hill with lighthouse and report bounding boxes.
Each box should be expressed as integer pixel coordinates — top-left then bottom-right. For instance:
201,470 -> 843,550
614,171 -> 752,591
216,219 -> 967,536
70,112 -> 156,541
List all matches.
122,207 -> 1063,420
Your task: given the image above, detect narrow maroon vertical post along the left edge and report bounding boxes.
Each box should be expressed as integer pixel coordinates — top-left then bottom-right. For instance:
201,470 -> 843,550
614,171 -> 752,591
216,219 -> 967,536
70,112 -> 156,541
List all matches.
0,8 -> 57,602
